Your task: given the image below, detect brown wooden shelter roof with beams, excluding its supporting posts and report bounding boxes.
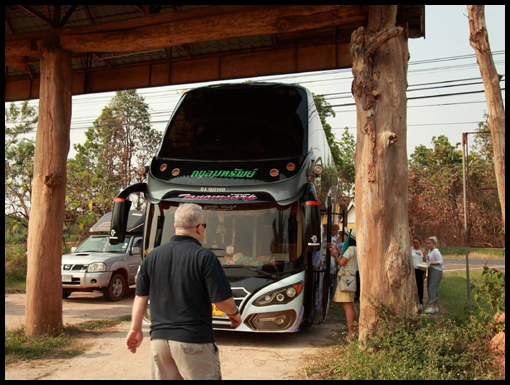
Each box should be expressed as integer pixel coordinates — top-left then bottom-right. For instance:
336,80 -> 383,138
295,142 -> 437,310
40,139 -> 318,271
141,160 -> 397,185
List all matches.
5,5 -> 425,101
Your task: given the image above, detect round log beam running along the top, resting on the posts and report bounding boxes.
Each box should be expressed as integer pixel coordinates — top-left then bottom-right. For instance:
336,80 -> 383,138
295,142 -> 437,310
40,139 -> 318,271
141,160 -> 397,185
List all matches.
5,5 -> 366,57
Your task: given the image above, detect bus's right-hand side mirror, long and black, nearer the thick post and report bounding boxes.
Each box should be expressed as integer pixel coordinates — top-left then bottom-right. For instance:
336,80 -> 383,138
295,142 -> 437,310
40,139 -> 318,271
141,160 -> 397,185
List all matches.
303,183 -> 321,253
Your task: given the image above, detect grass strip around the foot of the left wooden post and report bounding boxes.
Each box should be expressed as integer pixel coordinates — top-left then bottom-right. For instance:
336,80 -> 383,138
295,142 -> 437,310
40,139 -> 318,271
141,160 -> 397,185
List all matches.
5,316 -> 131,365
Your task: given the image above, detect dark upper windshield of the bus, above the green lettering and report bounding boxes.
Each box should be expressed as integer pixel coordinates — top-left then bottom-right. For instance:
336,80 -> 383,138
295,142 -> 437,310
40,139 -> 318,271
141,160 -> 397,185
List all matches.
158,85 -> 308,161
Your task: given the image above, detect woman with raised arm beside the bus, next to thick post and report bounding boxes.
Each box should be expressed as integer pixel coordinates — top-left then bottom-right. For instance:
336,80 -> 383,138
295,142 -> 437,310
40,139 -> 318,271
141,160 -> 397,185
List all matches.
328,229 -> 359,338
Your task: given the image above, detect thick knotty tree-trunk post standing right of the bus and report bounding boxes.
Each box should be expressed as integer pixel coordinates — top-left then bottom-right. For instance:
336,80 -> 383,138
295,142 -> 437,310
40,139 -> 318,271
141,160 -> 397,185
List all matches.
349,5 -> 418,341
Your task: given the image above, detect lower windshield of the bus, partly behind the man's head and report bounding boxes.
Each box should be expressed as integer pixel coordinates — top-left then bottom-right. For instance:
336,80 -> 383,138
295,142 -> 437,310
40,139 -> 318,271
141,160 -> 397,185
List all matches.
146,202 -> 304,277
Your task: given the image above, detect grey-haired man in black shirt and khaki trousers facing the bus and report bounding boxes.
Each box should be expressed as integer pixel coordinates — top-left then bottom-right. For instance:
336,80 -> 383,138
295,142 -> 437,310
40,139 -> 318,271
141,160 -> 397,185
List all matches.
126,203 -> 241,380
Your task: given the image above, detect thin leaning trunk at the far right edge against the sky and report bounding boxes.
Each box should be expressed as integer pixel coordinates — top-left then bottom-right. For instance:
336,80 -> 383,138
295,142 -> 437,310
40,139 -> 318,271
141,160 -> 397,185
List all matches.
468,5 -> 505,231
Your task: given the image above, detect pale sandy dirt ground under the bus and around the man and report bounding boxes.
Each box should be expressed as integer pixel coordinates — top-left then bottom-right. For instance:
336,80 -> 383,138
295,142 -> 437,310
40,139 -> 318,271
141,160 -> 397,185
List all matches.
5,293 -> 346,380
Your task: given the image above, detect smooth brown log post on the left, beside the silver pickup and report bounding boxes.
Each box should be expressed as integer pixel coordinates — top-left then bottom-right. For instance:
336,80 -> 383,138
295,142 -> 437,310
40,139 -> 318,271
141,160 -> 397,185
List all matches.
25,38 -> 71,336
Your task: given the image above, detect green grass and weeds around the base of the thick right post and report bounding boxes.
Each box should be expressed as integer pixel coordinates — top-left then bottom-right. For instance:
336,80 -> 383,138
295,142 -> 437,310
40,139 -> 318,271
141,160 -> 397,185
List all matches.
306,269 -> 505,380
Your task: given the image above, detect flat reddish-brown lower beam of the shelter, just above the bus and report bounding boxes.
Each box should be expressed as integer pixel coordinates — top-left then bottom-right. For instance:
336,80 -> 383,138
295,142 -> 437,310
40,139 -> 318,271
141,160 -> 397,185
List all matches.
5,42 -> 351,101
